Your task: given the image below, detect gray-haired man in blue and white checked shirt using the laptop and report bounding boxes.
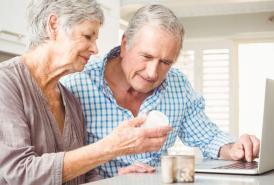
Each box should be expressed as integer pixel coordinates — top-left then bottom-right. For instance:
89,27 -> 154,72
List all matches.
63,5 -> 259,177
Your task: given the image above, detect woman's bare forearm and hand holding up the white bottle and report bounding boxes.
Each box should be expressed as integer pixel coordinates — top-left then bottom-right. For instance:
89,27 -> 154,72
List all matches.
63,118 -> 171,182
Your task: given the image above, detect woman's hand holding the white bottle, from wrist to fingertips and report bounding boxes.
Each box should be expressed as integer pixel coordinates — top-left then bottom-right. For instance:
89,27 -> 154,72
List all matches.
103,117 -> 171,156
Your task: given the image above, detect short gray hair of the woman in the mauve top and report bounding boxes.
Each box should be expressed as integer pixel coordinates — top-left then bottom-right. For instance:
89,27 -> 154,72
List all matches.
27,0 -> 104,48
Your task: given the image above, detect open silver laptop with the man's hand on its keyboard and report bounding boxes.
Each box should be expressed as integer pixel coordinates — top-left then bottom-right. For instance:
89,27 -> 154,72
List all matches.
195,79 -> 274,175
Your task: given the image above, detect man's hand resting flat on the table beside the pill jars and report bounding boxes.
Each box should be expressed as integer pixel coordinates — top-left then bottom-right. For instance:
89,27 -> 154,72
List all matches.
118,162 -> 155,175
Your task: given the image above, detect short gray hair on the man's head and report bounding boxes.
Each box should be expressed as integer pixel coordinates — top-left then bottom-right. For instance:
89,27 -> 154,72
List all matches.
124,4 -> 184,49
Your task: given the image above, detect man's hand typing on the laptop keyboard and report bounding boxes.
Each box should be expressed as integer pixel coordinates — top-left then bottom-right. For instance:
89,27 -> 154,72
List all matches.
219,134 -> 260,162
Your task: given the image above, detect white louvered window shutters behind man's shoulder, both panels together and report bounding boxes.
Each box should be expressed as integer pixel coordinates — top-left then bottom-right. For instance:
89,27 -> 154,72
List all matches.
174,49 -> 230,132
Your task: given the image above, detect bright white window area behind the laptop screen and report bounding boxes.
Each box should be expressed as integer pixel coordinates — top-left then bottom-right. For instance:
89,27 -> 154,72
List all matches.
238,42 -> 274,138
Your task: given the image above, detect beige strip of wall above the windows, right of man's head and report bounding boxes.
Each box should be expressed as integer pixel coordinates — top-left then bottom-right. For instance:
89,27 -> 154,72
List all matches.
181,12 -> 274,40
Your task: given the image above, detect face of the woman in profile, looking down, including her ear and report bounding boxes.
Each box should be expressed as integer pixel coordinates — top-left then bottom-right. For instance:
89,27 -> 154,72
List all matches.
53,20 -> 101,73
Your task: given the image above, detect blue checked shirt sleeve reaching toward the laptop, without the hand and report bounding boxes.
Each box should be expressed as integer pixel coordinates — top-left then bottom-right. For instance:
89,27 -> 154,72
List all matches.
173,75 -> 234,159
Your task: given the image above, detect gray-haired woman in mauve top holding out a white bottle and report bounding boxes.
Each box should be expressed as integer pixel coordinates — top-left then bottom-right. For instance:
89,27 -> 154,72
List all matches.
0,0 -> 170,185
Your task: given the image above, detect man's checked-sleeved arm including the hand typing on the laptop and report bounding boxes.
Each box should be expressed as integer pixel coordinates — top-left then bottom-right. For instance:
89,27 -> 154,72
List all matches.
178,78 -> 260,161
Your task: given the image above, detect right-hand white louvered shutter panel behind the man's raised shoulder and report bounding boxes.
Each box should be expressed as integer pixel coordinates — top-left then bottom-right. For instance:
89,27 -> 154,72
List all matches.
202,49 -> 230,132
